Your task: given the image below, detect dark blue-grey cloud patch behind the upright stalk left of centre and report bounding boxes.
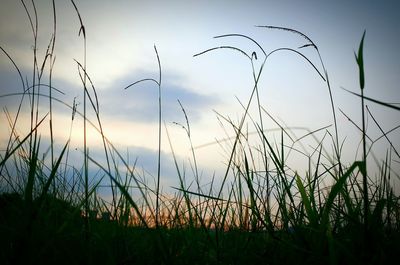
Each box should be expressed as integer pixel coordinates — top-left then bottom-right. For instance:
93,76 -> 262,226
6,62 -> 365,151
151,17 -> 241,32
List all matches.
92,70 -> 219,123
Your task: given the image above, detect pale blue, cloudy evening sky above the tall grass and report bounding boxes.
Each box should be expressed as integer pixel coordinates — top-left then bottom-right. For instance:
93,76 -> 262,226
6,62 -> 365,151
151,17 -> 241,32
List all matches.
0,0 -> 400,196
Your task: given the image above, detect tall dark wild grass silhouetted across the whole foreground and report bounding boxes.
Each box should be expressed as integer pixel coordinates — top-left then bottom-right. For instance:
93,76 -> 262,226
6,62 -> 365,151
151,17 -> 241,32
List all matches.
0,1 -> 400,264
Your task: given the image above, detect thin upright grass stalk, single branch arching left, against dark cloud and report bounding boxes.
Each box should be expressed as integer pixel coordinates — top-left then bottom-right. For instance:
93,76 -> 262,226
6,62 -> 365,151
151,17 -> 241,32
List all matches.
124,45 -> 162,228
